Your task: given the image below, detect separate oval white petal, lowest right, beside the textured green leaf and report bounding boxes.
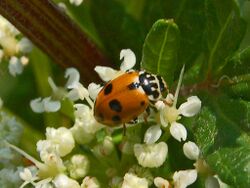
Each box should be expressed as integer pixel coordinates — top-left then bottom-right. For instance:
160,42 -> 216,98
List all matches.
183,141 -> 200,160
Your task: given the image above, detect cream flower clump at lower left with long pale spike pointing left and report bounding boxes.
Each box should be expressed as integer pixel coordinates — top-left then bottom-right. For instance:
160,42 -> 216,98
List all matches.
9,127 -> 100,188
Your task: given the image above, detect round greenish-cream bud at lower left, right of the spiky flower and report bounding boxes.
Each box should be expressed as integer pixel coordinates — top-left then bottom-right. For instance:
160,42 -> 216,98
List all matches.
68,154 -> 89,179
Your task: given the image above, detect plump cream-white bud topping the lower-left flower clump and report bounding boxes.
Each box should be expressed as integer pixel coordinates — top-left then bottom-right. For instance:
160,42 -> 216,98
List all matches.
46,127 -> 75,157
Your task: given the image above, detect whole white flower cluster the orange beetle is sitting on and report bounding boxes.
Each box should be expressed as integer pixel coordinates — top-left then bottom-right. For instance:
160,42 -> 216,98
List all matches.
10,49 -> 227,188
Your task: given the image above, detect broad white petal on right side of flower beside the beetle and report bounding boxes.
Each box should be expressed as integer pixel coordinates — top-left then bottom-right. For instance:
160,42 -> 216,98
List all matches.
178,96 -> 201,117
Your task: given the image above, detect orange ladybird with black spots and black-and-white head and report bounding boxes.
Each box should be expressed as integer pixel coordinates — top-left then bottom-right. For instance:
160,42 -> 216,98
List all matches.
94,71 -> 167,126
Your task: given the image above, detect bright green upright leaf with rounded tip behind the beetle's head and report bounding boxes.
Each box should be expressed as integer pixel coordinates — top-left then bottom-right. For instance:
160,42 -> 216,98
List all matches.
141,19 -> 180,85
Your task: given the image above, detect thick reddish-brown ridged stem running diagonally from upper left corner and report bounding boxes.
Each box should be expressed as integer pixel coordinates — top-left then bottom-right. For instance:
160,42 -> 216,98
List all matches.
0,0 -> 110,83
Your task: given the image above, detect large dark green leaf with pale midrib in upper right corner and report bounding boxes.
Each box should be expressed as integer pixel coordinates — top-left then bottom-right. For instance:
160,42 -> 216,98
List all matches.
204,0 -> 246,77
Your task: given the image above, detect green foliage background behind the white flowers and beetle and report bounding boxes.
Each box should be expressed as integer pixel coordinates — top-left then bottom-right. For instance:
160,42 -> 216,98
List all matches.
0,0 -> 250,188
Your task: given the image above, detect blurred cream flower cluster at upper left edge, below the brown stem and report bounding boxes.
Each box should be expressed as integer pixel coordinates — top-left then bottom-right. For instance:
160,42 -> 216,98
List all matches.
0,15 -> 33,76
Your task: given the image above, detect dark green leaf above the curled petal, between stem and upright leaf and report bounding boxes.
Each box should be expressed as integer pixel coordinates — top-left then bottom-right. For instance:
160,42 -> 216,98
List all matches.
90,0 -> 145,65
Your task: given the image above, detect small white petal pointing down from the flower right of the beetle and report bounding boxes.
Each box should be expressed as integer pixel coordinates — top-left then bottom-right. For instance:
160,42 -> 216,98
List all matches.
170,122 -> 187,142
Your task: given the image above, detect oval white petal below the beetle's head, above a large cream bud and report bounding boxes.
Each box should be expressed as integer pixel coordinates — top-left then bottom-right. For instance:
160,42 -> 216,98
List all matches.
144,125 -> 162,144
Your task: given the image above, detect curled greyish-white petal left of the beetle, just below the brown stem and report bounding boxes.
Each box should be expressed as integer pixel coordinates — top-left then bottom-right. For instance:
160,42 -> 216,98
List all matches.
64,68 -> 80,89
